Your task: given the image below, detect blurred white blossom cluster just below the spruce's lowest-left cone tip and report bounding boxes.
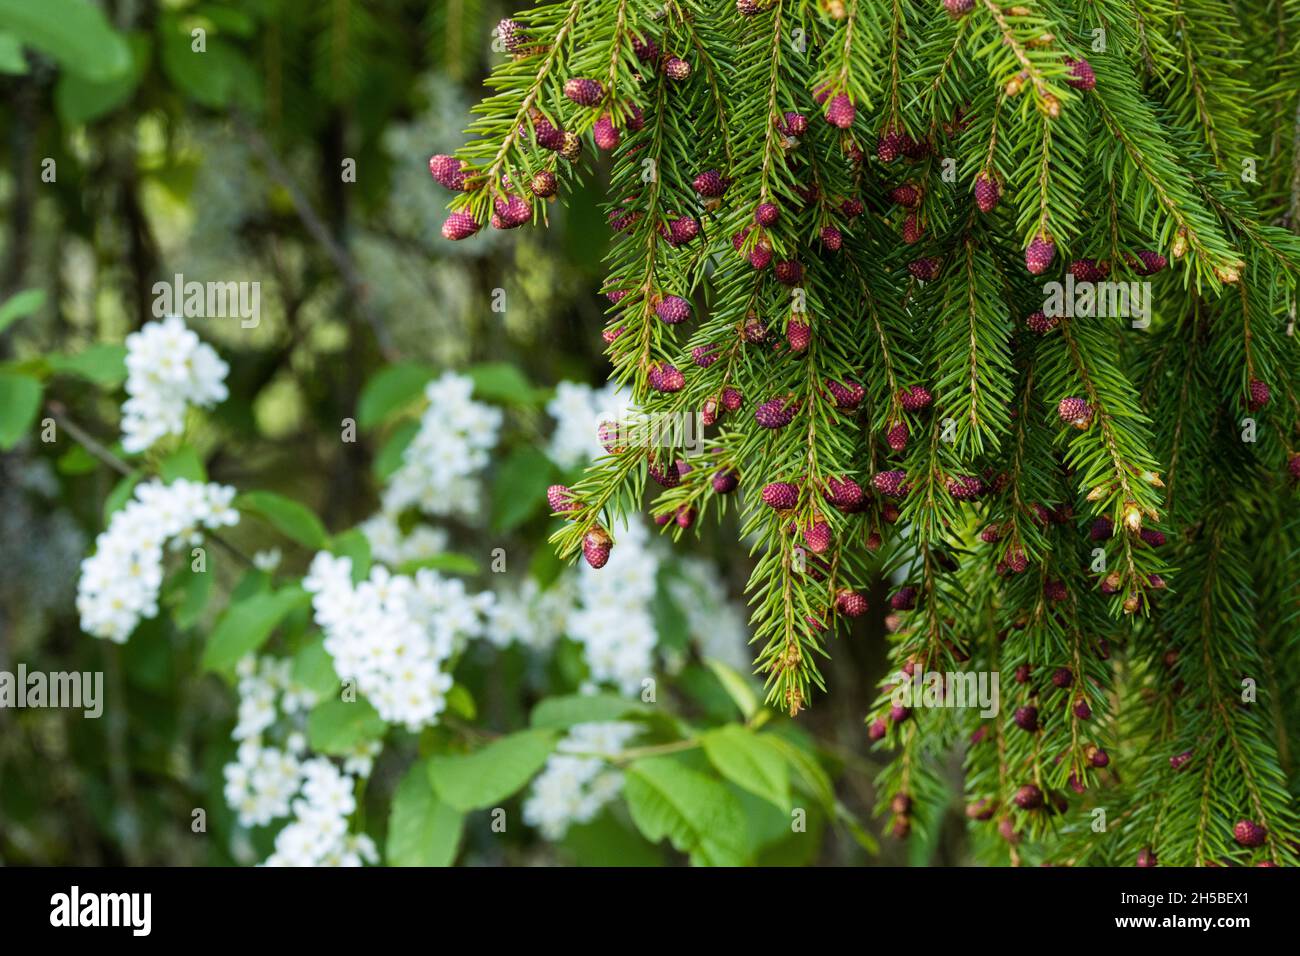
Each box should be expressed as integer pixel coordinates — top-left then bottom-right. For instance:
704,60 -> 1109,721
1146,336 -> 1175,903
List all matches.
566,522 -> 659,695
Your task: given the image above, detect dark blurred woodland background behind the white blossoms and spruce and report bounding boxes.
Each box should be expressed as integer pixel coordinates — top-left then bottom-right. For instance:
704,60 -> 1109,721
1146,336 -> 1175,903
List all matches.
0,0 -> 915,864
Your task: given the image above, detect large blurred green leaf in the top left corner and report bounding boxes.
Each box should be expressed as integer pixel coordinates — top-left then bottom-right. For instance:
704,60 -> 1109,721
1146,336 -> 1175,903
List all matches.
0,0 -> 131,81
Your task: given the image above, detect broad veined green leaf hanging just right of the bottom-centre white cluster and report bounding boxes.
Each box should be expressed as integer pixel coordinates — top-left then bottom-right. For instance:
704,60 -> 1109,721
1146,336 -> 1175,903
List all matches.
623,757 -> 749,866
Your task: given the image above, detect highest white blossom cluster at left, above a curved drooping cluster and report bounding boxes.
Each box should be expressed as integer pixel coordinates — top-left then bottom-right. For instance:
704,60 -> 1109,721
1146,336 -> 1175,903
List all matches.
122,315 -> 230,454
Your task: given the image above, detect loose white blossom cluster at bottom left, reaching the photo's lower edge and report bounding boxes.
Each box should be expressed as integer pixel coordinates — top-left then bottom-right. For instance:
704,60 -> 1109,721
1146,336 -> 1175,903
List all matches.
222,656 -> 381,866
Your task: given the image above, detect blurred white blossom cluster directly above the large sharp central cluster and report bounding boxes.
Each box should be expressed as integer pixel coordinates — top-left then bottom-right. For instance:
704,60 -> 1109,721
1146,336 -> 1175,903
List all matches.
382,372 -> 502,516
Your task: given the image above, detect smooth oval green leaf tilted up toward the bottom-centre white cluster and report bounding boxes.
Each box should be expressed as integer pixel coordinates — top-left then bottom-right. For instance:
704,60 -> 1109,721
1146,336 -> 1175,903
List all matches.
429,730 -> 558,810
